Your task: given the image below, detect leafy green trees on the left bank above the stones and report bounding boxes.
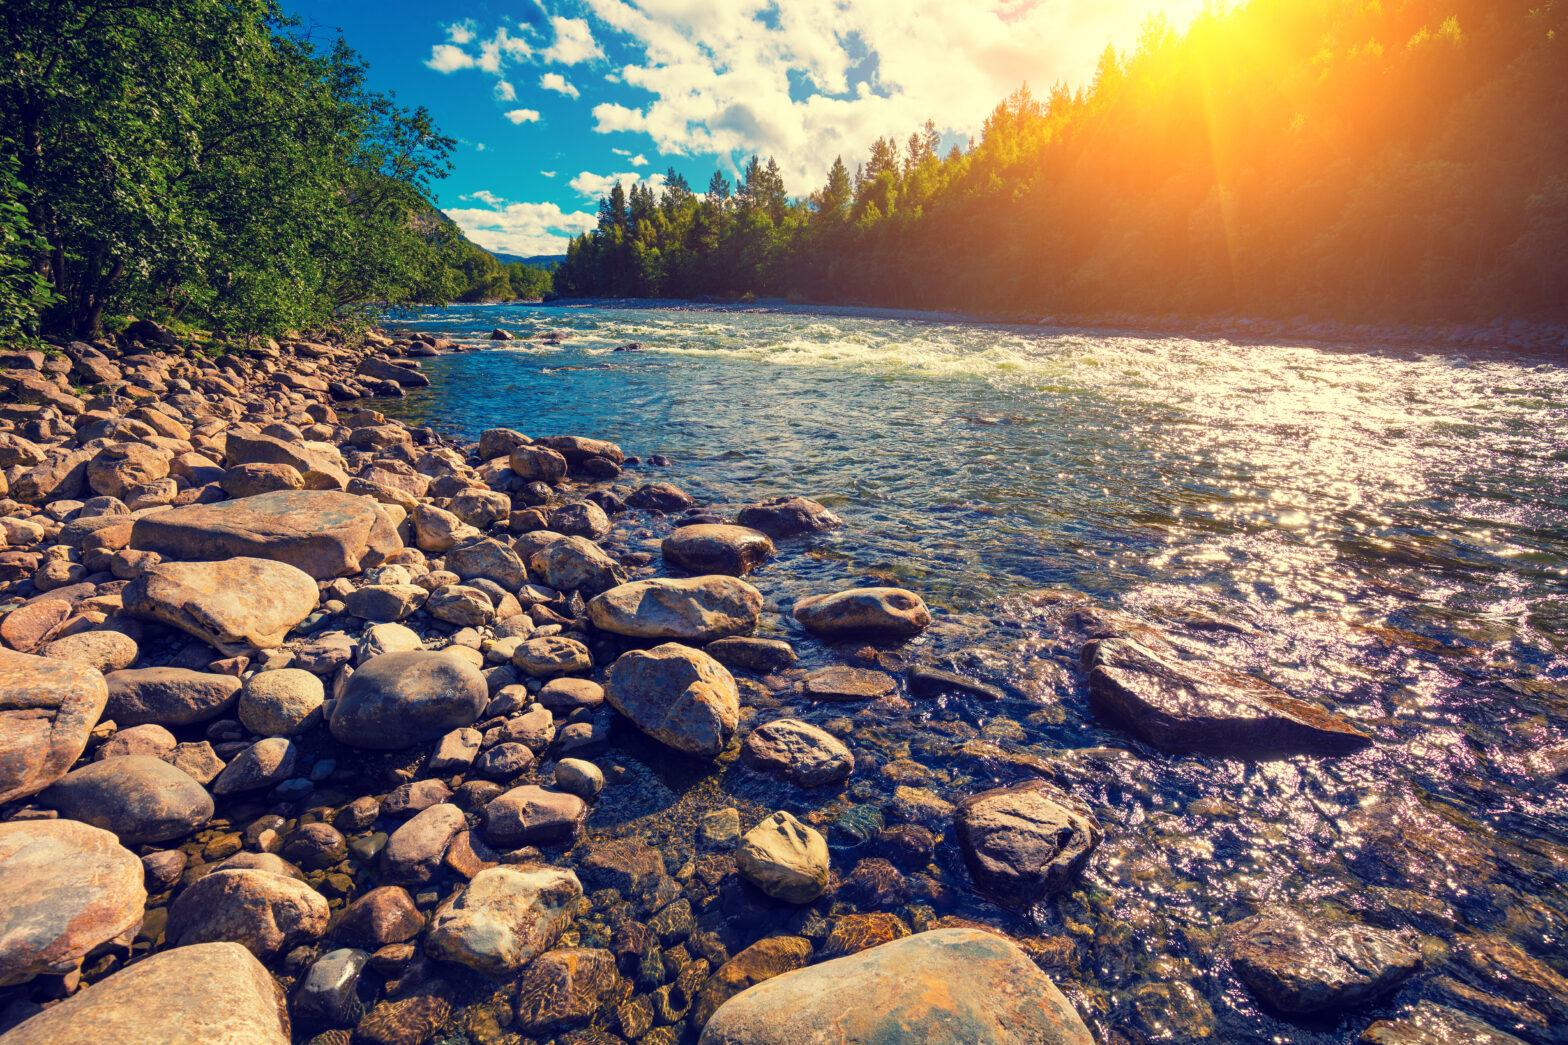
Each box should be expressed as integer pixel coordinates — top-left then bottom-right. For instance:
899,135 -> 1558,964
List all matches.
0,0 -> 533,337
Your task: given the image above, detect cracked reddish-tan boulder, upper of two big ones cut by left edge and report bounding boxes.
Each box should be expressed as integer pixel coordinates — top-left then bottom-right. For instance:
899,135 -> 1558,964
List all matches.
0,650 -> 108,805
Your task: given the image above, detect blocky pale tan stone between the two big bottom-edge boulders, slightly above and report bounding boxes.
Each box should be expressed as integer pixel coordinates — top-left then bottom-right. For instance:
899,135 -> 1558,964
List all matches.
425,865 -> 582,974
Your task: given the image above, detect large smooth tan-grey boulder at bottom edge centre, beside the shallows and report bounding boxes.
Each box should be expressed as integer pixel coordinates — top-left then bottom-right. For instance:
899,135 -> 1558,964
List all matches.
699,929 -> 1094,1045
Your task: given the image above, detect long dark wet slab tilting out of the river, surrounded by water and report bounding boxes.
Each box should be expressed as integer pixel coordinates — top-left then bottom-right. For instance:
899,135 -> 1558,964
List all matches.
1083,639 -> 1372,758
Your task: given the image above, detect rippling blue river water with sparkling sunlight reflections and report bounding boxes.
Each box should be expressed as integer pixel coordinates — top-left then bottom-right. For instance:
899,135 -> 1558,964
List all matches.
376,306 -> 1568,1043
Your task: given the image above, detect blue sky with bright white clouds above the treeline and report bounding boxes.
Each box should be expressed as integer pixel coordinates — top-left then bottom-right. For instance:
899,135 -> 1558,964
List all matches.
285,0 -> 1203,256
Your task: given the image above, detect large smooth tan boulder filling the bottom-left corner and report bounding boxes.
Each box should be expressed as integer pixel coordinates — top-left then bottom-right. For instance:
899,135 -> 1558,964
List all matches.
5,943 -> 290,1045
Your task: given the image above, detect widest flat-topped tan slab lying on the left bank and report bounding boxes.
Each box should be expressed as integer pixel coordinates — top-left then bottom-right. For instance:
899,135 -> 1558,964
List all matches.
130,490 -> 403,581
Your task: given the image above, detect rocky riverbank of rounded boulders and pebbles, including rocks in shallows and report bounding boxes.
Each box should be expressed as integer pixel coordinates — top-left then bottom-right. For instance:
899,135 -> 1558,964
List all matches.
0,323 -> 1568,1045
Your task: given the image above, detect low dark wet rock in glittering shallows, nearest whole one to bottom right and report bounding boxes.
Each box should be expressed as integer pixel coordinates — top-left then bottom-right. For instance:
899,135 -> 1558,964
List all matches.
1226,908 -> 1421,1014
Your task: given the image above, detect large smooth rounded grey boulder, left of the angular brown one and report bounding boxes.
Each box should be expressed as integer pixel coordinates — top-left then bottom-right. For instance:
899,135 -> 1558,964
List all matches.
329,650 -> 489,752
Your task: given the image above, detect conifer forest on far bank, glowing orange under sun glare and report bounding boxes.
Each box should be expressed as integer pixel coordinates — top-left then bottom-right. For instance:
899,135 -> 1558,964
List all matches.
555,0 -> 1568,320
